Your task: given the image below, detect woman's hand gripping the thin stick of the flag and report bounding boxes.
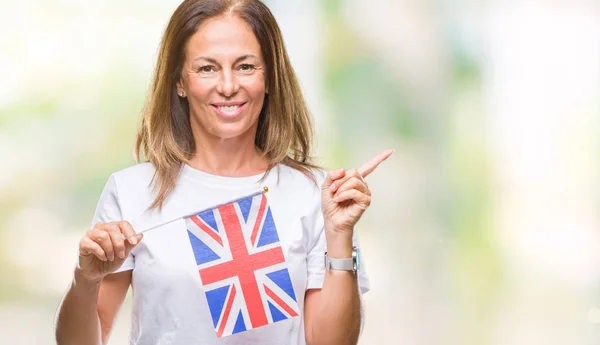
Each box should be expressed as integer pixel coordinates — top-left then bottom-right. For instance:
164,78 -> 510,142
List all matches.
78,221 -> 143,282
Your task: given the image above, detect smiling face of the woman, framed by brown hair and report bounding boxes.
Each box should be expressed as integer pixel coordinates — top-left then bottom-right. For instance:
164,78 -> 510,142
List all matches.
177,15 -> 266,143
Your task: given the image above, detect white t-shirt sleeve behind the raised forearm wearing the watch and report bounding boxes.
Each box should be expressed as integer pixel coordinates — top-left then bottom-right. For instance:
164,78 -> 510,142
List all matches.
303,204 -> 370,294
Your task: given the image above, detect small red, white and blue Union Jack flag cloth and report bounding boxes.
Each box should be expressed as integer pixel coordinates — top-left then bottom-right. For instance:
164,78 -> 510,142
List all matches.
185,194 -> 299,338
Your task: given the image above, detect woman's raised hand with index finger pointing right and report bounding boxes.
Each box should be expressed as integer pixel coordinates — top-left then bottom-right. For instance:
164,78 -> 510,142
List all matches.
321,150 -> 394,244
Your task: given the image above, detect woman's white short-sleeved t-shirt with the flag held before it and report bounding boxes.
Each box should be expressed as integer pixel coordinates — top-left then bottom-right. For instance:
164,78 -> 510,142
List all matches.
92,163 -> 369,345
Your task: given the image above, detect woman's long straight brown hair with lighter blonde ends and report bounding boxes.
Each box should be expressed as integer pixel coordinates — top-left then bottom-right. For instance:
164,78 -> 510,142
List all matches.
135,0 -> 316,209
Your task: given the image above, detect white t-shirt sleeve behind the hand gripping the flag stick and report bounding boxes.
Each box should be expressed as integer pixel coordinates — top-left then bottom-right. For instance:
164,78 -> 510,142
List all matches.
91,174 -> 135,273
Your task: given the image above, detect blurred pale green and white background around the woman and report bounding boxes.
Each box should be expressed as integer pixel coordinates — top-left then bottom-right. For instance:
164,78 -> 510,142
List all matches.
0,0 -> 600,345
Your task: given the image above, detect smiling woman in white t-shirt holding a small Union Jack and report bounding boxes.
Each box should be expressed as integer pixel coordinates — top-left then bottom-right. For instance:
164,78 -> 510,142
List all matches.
56,0 -> 391,345
